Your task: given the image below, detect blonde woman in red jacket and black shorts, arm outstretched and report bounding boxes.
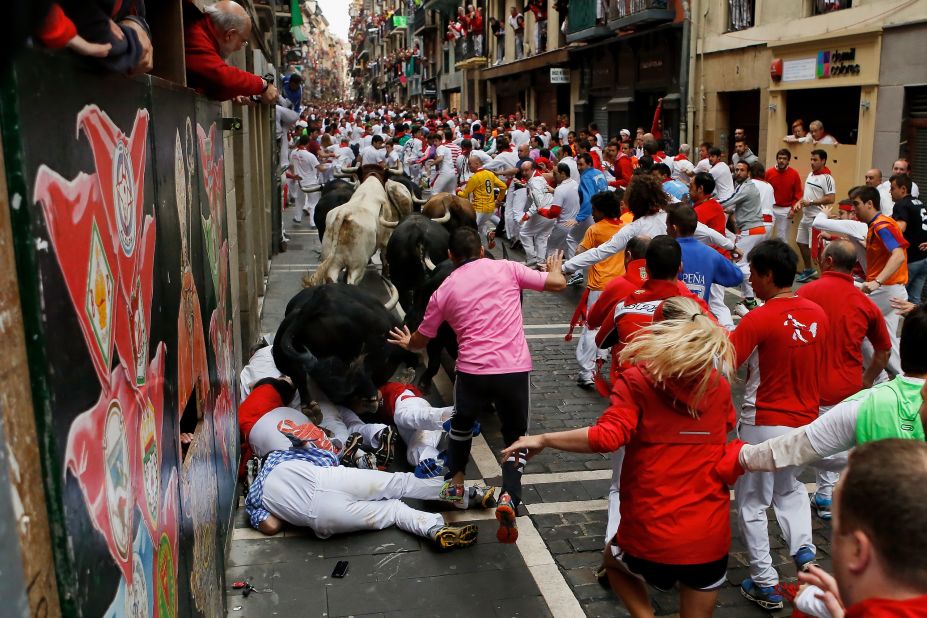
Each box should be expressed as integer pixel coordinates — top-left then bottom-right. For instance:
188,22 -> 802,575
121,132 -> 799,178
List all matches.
503,296 -> 736,617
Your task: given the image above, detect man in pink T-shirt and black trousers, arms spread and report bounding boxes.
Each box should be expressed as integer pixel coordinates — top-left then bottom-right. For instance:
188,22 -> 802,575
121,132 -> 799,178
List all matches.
389,228 -> 566,543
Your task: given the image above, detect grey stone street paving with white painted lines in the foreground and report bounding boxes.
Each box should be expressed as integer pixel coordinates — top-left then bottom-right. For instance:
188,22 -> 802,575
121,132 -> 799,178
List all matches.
227,219 -> 830,618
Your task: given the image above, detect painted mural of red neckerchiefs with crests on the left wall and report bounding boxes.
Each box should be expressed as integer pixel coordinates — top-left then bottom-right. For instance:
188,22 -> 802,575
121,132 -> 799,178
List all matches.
0,52 -> 239,618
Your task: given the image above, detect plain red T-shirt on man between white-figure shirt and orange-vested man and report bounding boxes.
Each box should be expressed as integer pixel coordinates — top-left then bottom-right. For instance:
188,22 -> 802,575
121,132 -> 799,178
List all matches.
796,271 -> 892,406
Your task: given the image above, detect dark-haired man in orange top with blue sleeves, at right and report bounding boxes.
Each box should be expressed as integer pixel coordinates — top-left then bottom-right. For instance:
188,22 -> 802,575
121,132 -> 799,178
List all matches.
850,187 -> 908,375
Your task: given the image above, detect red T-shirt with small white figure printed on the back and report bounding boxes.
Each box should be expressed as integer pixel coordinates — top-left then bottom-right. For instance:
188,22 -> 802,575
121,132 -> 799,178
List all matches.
731,296 -> 830,427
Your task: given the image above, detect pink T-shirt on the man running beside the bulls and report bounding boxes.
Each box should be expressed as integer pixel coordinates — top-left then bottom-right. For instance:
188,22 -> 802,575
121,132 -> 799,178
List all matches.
418,258 -> 547,375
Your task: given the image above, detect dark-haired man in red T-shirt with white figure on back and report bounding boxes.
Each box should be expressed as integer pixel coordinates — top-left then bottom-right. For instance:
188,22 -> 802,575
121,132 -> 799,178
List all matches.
731,239 -> 829,609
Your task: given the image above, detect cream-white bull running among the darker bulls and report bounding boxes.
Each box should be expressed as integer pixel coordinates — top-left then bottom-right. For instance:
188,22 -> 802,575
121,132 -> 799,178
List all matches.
303,175 -> 412,300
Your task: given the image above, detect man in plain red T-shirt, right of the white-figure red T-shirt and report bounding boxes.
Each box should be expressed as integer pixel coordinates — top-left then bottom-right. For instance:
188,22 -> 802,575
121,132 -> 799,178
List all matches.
797,240 -> 892,519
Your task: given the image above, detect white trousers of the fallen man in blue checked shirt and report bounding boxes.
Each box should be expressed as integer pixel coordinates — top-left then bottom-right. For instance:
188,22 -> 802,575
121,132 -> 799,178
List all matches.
264,465 -> 444,539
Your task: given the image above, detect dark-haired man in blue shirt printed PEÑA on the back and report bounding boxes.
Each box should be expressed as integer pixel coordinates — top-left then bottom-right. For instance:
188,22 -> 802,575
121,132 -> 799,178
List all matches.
666,206 -> 744,303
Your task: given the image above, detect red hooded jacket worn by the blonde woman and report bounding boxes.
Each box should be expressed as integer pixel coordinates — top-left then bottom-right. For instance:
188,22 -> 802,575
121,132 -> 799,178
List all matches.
588,366 -> 734,564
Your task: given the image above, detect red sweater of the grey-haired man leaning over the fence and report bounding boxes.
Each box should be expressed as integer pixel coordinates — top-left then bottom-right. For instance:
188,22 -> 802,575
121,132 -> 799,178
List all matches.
184,15 -> 265,101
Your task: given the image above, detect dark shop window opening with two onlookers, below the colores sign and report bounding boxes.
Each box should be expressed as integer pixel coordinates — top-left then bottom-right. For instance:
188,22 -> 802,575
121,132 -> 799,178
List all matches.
782,86 -> 860,145
